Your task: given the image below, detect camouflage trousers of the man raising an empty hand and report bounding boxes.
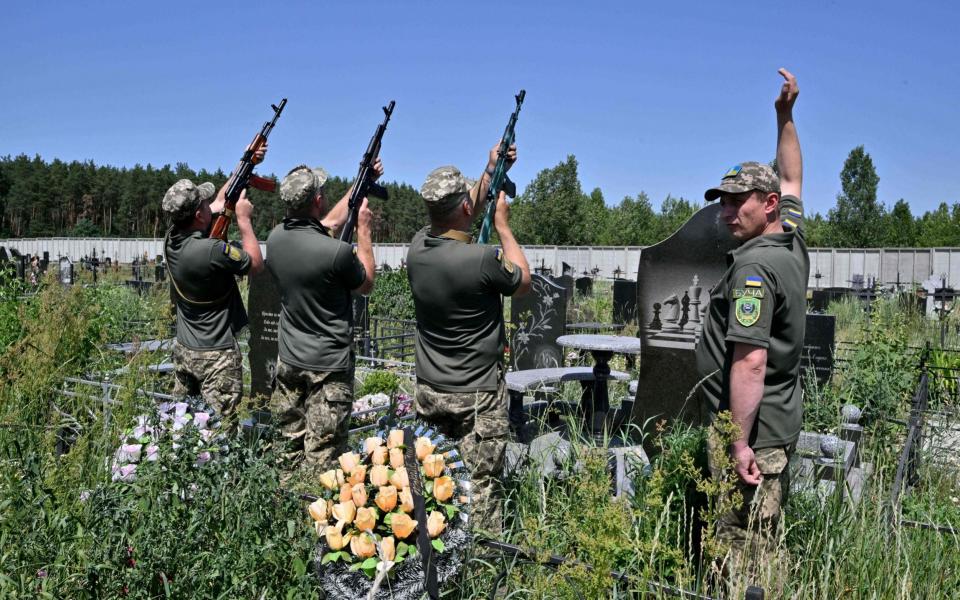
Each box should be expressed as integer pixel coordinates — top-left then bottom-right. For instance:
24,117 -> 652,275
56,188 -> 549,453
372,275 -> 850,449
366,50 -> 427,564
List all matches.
707,428 -> 793,598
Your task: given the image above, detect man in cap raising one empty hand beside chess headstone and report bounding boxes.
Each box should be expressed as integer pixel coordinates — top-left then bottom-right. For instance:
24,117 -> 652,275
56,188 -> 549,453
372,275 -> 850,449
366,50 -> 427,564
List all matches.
697,69 -> 810,585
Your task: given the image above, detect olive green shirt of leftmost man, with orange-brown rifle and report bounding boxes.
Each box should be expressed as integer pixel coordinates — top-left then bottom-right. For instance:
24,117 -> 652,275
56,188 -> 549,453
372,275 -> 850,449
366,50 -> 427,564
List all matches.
164,227 -> 250,350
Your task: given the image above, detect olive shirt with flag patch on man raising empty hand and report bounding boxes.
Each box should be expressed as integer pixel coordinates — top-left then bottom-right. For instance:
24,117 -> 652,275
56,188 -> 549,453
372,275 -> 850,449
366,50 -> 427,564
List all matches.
697,196 -> 810,448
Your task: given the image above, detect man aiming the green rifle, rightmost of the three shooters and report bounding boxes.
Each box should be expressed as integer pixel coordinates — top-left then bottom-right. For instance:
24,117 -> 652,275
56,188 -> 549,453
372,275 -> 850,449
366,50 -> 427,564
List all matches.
407,146 -> 530,534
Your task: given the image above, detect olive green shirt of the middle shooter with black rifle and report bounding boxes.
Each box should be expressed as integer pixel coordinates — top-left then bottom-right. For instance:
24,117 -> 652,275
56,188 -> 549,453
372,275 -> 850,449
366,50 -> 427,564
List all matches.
267,218 -> 367,371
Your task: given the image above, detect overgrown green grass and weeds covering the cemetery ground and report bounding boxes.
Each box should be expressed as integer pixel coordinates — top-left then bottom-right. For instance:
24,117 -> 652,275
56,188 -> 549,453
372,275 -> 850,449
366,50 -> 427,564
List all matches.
0,273 -> 960,599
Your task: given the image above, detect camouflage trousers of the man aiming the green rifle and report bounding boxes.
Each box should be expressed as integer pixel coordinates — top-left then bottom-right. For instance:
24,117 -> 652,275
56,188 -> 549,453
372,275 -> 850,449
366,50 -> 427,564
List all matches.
415,380 -> 510,535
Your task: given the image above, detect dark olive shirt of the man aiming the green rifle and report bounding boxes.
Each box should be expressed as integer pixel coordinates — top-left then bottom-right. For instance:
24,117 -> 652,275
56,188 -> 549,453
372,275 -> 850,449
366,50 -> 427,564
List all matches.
407,228 -> 521,392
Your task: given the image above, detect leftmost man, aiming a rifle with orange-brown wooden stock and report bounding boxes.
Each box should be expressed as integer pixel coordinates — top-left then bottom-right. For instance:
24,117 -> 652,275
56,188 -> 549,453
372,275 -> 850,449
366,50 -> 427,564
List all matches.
162,171 -> 265,422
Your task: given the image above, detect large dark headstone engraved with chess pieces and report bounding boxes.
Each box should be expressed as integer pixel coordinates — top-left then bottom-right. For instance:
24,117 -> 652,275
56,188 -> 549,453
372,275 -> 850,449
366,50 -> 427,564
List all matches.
633,203 -> 737,429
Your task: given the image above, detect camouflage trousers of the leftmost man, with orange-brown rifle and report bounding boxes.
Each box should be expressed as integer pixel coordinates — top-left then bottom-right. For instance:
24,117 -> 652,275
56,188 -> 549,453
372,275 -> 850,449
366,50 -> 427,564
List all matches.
173,341 -> 243,421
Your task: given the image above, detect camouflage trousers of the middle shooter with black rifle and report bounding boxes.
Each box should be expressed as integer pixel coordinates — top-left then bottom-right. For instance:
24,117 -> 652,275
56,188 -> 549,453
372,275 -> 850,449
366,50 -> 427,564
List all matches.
270,361 -> 353,473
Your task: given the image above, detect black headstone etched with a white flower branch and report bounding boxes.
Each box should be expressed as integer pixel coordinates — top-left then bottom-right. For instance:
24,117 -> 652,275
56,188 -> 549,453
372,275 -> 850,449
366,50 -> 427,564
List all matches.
510,274 -> 568,371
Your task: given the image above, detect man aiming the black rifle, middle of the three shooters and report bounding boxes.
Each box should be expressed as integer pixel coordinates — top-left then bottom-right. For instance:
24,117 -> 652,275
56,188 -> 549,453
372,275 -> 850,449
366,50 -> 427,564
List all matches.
267,159 -> 383,476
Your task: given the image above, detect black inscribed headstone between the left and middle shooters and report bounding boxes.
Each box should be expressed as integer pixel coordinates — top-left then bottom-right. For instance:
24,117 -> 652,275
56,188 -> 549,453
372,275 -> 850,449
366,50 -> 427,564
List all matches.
247,269 -> 280,398
